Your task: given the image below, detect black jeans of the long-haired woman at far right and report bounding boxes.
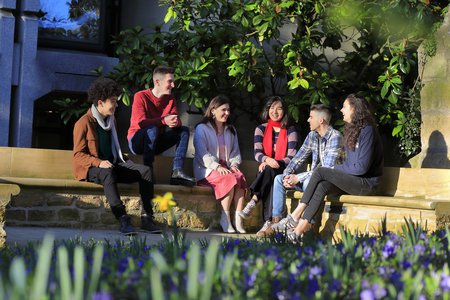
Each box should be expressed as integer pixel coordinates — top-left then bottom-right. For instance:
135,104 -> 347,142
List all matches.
301,167 -> 375,223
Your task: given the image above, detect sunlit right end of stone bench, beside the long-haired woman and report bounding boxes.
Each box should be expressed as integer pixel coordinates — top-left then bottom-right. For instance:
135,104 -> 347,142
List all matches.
286,167 -> 450,238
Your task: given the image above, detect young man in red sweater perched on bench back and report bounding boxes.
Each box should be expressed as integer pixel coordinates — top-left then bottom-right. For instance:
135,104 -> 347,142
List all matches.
127,66 -> 195,186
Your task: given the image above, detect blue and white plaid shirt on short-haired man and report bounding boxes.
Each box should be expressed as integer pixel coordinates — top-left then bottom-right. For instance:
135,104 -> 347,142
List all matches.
283,126 -> 342,182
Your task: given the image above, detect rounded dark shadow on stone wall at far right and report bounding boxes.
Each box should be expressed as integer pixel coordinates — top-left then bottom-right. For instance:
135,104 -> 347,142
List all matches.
422,130 -> 450,169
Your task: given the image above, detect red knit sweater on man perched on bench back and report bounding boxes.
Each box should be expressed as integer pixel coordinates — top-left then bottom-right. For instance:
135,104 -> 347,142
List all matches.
127,89 -> 181,140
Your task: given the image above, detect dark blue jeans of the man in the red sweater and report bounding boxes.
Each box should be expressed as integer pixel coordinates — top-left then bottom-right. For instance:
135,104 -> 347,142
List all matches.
128,126 -> 189,170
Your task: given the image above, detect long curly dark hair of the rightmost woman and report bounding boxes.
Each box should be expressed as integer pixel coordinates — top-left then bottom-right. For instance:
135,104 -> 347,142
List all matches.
344,94 -> 375,150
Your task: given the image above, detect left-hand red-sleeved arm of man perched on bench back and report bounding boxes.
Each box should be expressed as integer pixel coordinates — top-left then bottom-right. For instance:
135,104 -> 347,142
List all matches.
131,92 -> 164,128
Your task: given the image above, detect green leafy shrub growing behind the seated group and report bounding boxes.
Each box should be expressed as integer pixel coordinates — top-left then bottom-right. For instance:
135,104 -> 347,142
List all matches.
111,0 -> 449,157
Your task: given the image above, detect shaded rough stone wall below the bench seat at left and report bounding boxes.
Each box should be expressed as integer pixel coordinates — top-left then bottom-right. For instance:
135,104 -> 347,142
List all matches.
6,185 -> 262,230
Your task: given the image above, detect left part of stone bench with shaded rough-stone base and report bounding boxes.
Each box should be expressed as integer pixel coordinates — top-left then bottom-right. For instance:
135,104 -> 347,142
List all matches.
0,147 -> 260,234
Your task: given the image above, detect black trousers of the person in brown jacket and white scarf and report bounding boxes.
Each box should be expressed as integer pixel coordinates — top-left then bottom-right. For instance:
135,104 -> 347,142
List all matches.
88,160 -> 153,219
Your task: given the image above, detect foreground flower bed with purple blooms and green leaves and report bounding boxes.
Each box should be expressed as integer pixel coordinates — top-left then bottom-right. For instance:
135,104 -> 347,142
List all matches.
0,222 -> 450,299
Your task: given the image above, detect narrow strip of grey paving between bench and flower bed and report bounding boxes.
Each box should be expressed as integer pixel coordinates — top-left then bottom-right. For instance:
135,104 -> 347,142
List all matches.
5,226 -> 256,245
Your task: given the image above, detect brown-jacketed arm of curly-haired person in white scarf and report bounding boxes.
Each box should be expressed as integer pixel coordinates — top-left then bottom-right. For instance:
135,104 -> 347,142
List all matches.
73,121 -> 102,168
